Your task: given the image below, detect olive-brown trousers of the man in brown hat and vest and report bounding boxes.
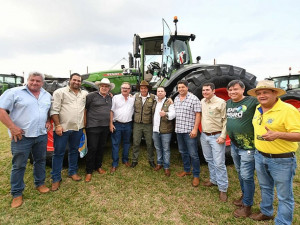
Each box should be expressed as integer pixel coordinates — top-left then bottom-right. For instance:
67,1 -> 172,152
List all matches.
132,123 -> 154,162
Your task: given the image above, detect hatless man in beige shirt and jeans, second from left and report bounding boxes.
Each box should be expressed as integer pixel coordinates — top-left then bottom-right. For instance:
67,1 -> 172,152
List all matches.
50,73 -> 88,191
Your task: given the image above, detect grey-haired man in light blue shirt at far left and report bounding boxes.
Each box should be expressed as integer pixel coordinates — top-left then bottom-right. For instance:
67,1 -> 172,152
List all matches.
0,72 -> 51,208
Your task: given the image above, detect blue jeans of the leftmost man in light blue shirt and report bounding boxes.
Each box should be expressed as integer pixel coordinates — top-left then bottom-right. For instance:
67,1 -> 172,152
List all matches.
10,134 -> 47,198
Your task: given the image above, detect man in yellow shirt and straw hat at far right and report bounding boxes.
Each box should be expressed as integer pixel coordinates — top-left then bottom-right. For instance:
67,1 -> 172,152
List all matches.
247,80 -> 300,224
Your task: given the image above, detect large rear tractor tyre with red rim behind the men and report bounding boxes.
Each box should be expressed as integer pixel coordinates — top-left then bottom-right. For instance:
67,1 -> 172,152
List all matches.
184,65 -> 256,163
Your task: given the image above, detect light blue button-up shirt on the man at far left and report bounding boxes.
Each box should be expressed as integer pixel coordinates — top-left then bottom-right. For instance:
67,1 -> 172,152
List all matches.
0,86 -> 51,137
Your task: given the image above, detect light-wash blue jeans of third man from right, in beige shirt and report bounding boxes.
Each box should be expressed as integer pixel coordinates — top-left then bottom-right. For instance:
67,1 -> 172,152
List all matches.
201,132 -> 228,192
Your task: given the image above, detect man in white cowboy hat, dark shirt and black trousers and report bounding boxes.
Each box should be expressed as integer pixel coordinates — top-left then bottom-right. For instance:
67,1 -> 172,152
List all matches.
85,78 -> 115,182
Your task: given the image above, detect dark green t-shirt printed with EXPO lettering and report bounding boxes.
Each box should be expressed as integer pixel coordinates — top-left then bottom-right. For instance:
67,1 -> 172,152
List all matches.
226,96 -> 258,150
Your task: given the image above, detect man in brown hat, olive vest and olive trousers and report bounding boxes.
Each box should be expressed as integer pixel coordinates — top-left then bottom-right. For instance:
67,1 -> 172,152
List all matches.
131,80 -> 156,168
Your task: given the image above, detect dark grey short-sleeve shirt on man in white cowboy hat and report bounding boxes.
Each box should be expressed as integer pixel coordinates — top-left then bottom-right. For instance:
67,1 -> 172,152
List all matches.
85,91 -> 112,128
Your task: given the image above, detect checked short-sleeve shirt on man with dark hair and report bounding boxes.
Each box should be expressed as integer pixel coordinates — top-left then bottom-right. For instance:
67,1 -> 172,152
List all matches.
174,92 -> 201,133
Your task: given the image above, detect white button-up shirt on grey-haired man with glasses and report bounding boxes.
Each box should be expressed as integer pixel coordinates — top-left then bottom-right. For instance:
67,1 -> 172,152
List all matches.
111,94 -> 135,123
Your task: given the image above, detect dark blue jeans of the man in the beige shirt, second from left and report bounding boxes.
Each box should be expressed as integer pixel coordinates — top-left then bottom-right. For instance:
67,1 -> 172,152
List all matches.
51,129 -> 82,183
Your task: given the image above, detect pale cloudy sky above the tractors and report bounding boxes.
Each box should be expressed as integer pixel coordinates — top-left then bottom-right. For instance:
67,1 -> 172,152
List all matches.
0,0 -> 300,80
